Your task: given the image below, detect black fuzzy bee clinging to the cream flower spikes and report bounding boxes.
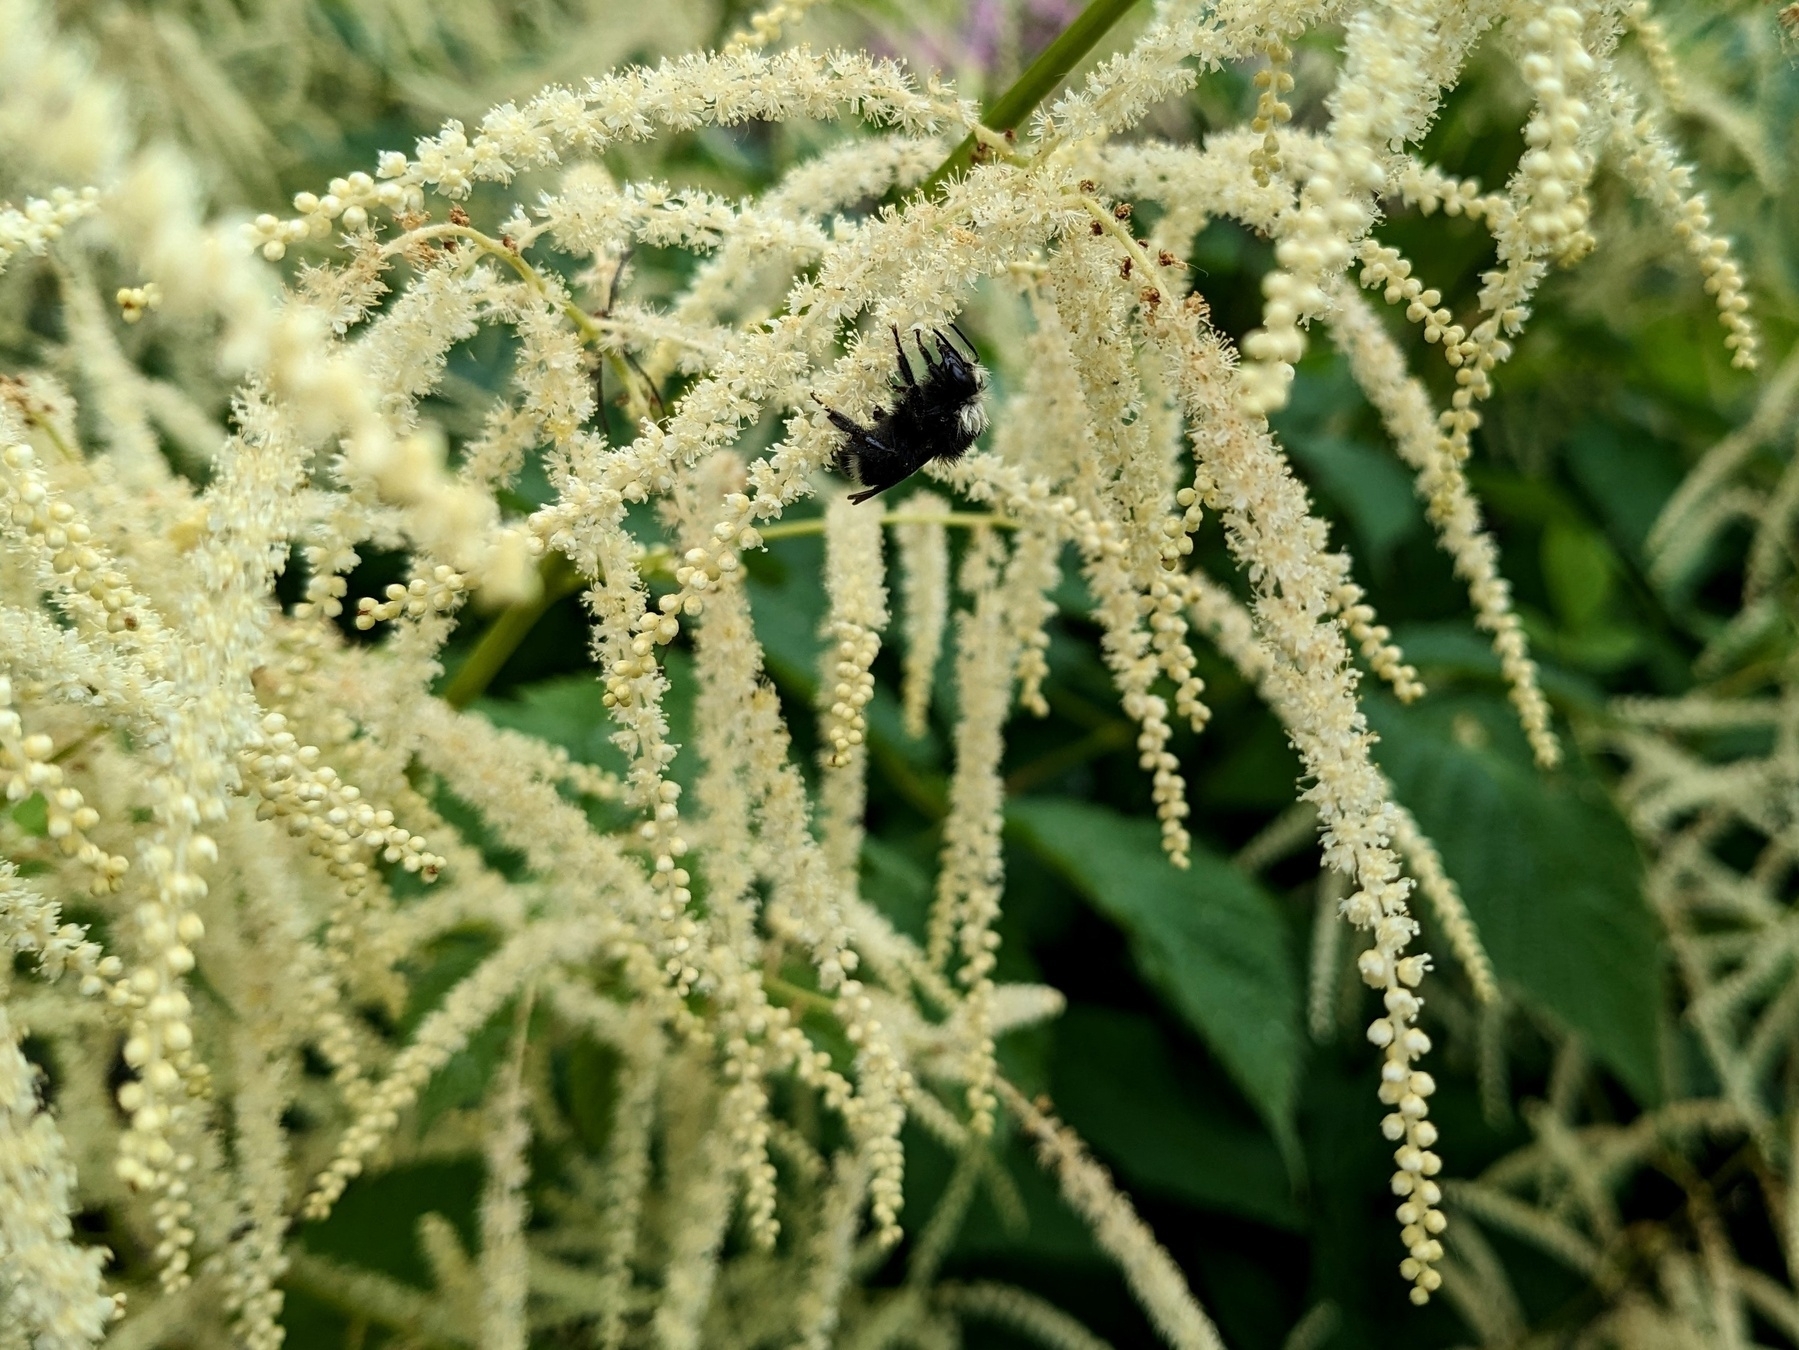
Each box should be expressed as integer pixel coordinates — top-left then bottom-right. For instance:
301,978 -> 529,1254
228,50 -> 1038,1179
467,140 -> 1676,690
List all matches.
824,324 -> 988,502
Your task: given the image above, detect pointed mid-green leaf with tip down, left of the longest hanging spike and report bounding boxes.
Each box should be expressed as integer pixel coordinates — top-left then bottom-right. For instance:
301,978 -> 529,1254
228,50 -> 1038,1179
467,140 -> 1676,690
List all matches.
1007,797 -> 1301,1157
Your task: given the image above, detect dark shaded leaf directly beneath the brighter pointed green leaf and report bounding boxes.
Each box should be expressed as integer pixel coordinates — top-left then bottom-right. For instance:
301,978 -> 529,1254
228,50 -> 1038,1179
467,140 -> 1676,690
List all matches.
1051,1004 -> 1301,1229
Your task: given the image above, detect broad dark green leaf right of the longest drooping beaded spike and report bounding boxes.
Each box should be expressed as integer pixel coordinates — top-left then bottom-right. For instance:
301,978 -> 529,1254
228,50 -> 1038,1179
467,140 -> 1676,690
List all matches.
1367,697 -> 1662,1103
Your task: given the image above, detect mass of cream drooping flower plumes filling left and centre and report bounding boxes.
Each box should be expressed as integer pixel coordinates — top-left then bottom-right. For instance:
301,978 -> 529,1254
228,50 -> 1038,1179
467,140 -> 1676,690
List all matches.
0,0 -> 1754,1346
